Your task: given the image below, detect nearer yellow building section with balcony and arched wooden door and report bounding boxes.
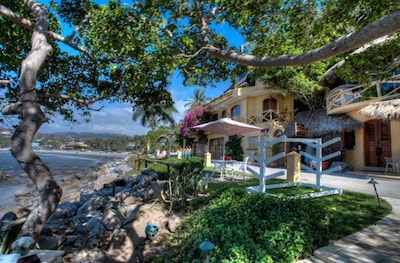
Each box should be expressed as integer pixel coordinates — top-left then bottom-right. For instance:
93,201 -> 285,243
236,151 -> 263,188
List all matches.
326,72 -> 400,173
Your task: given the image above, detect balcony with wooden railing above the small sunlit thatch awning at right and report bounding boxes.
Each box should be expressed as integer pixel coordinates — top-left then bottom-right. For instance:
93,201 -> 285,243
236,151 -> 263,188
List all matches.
326,74 -> 400,114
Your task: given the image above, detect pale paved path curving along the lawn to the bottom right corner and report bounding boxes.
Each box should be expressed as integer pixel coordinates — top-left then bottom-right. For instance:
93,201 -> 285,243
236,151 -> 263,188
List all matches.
244,166 -> 400,263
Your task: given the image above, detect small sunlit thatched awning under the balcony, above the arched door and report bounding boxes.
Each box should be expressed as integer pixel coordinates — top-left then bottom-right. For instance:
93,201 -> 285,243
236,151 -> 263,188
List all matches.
360,99 -> 400,120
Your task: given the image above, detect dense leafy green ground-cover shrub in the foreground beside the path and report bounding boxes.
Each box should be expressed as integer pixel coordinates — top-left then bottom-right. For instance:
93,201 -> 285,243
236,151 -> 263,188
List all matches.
155,188 -> 389,262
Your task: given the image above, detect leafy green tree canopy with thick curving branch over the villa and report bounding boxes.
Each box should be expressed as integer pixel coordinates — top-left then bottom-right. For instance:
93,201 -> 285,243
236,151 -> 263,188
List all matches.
166,0 -> 400,108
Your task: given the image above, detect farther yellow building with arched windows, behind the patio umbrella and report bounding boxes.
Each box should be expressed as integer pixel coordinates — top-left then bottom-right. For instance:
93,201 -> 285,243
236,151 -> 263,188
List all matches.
203,78 -> 294,161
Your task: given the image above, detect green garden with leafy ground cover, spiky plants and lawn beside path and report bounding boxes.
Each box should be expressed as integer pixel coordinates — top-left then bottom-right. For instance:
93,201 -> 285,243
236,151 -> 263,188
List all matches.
131,157 -> 391,262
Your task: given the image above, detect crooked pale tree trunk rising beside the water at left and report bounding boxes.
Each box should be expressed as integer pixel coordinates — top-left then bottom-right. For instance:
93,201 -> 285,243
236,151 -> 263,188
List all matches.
3,0 -> 62,240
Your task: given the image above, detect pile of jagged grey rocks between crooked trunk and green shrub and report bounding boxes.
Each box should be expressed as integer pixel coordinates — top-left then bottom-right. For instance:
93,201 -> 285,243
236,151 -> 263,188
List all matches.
10,163 -> 181,262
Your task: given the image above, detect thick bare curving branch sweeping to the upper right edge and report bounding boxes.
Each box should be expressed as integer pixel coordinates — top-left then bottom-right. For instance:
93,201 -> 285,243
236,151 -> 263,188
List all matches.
203,10 -> 400,68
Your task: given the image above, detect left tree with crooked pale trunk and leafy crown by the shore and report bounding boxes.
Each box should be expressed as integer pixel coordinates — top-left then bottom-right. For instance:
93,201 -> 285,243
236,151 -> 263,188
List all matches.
0,0 -> 173,239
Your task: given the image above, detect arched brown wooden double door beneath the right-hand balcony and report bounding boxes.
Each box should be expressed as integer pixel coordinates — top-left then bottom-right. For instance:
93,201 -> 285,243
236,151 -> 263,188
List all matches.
364,120 -> 392,167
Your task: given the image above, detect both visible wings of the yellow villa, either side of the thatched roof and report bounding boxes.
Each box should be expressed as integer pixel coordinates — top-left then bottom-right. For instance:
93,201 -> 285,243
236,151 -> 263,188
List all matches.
203,71 -> 400,171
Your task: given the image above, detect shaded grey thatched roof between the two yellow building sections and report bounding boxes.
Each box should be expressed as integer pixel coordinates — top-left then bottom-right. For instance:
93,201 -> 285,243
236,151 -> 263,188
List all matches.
285,109 -> 362,137
